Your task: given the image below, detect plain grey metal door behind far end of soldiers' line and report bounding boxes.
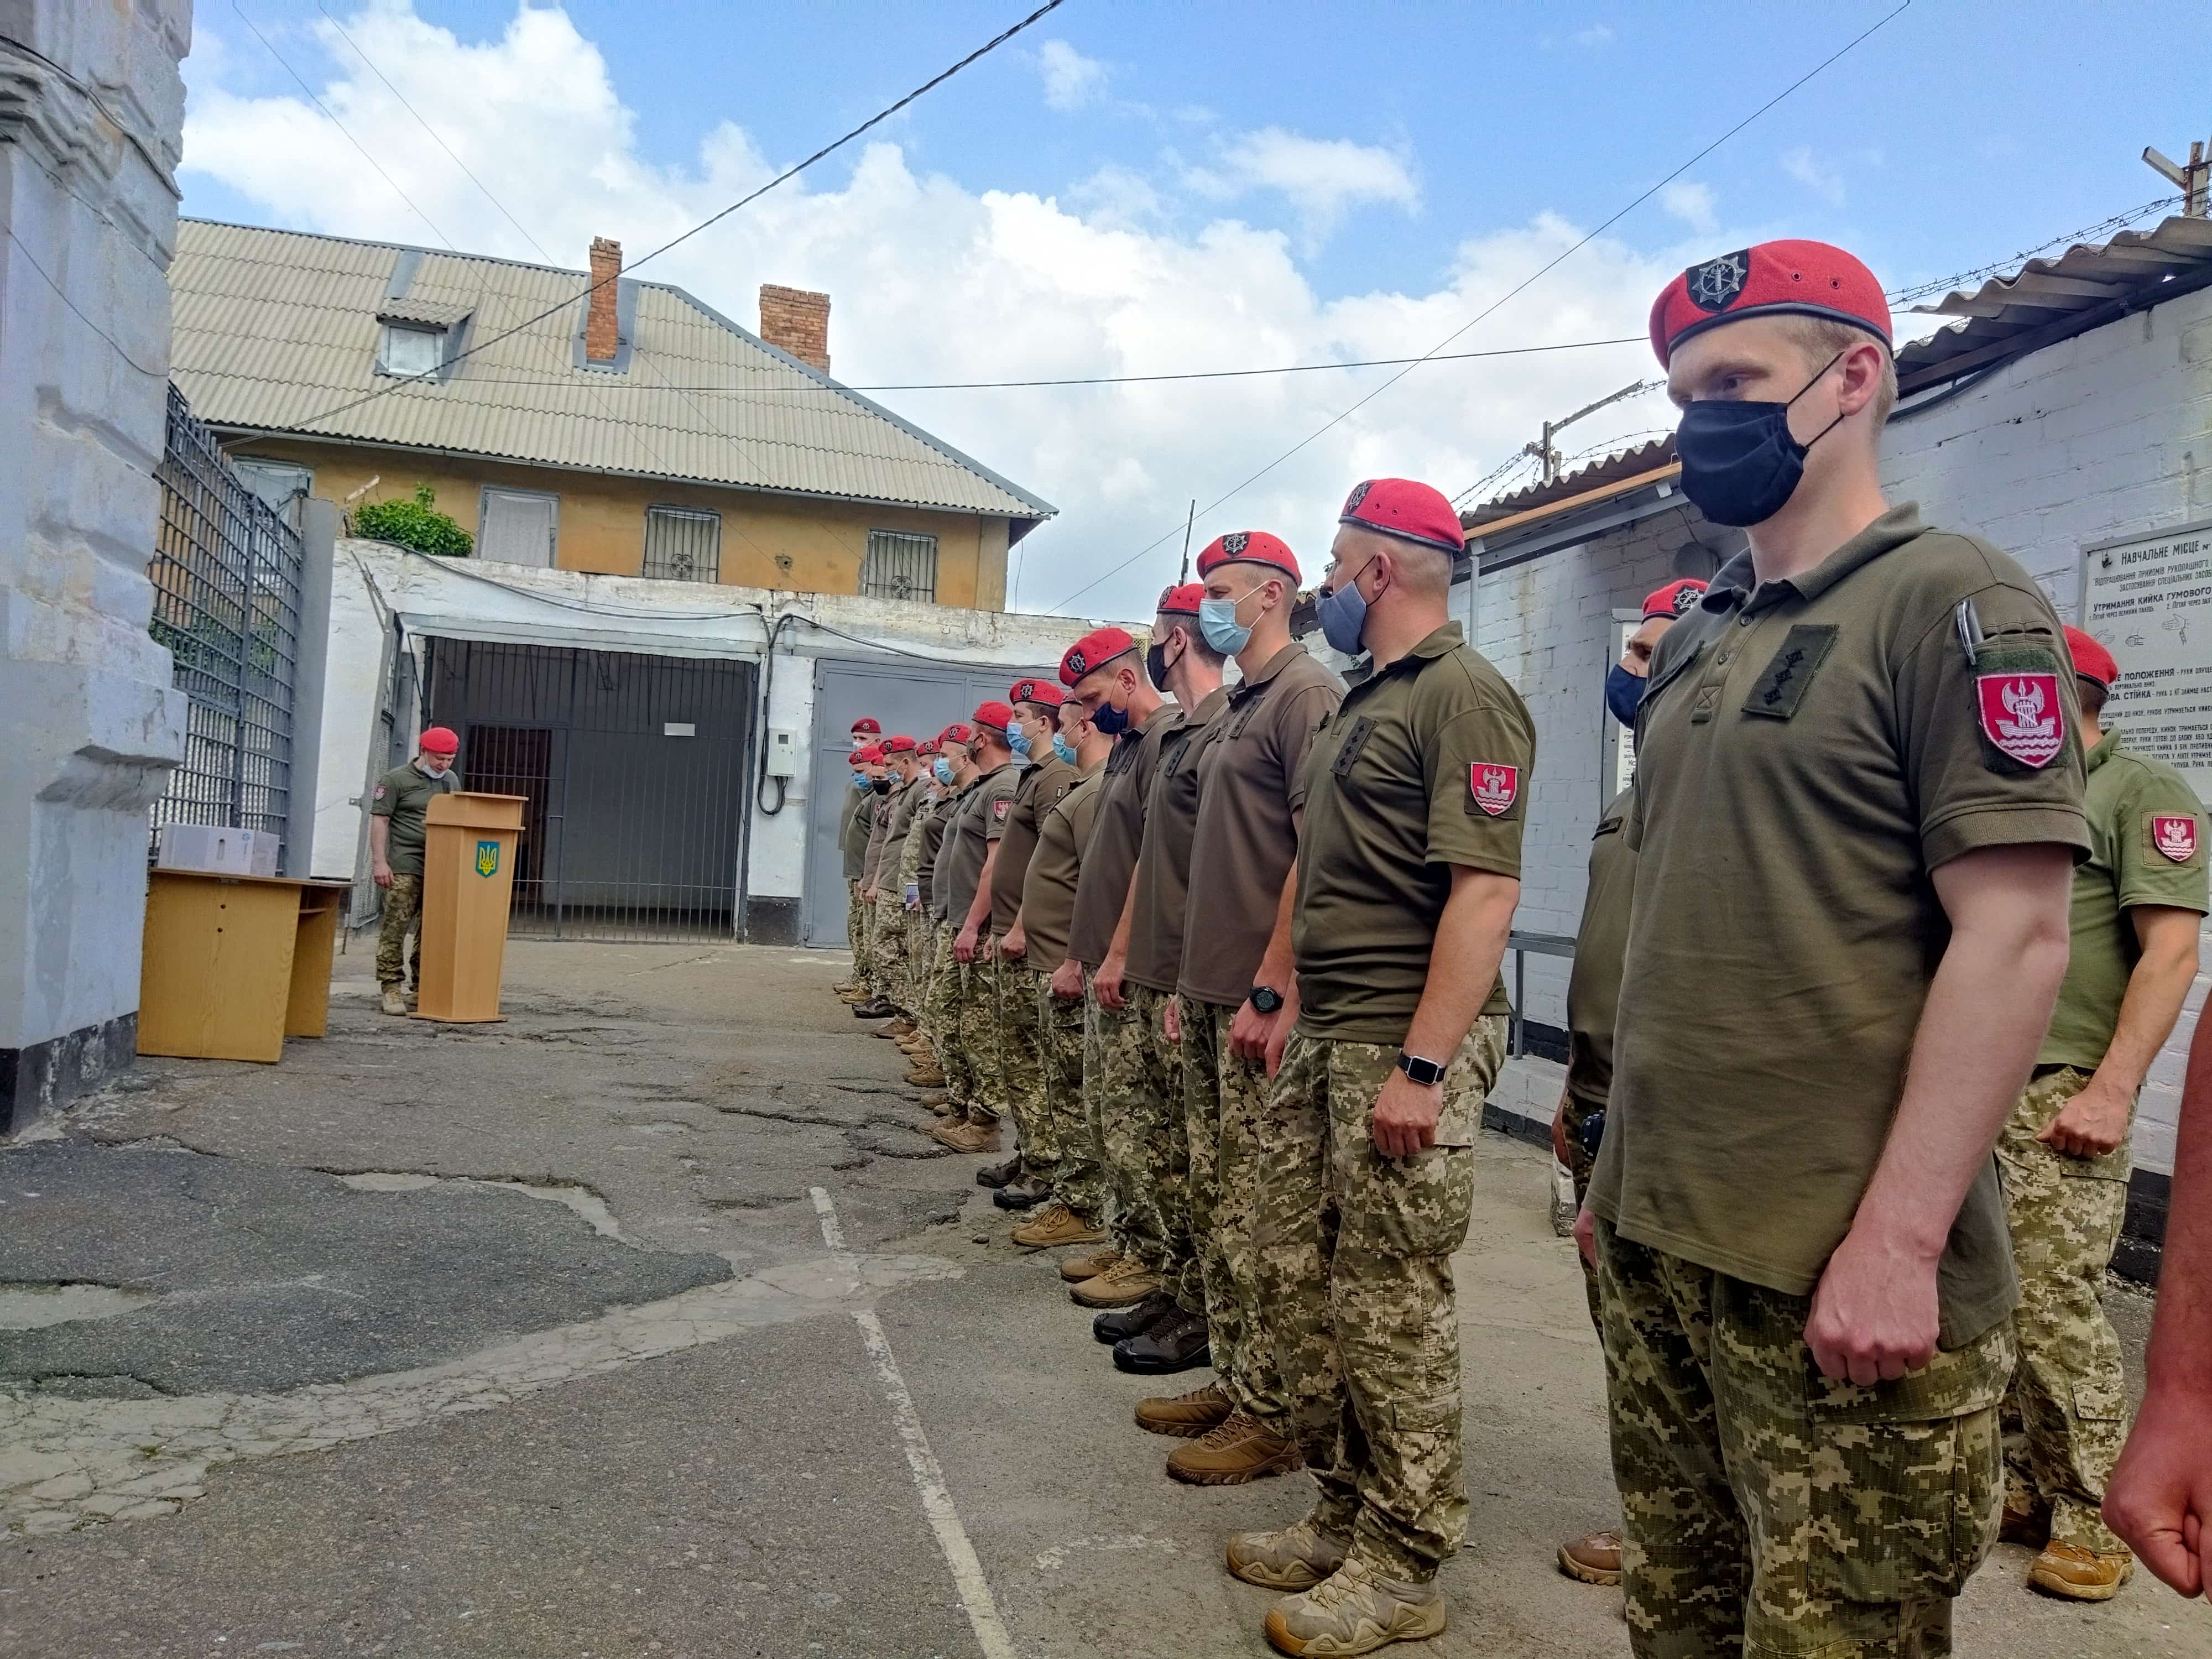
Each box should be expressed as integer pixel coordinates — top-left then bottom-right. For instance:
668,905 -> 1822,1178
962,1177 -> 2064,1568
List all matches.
801,657 -> 1060,949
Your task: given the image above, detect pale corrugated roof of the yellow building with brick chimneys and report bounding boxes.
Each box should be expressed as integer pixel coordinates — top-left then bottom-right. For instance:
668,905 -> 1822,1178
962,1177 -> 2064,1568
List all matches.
168,219 -> 1055,520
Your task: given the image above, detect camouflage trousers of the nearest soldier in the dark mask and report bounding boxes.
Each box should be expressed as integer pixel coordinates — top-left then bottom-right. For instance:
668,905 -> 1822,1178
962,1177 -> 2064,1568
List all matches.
1597,1219 -> 2013,1659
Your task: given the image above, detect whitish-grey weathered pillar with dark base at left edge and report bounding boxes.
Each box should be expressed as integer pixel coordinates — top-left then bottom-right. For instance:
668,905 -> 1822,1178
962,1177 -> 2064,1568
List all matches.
0,0 -> 192,1130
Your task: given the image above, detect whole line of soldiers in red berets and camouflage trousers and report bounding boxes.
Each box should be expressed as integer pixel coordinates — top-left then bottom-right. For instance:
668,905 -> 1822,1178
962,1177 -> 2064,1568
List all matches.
823,243 -> 2205,1659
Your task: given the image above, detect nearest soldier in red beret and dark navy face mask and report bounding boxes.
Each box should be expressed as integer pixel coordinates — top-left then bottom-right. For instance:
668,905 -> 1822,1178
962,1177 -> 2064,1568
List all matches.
1577,241 -> 2090,1655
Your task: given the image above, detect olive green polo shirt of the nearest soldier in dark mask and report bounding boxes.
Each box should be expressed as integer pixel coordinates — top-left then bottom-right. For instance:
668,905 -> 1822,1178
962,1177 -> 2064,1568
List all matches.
1590,504 -> 2090,1347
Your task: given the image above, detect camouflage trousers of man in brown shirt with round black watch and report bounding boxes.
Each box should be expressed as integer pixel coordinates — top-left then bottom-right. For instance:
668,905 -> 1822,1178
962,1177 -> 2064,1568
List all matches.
1181,998 -> 1290,1433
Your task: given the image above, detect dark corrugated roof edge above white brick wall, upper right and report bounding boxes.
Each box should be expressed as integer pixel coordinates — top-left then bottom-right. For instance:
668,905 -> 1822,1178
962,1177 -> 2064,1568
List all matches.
1898,219 -> 2212,394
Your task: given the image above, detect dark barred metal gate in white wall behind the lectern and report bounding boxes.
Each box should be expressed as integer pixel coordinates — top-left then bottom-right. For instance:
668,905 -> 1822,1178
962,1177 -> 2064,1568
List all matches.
425,639 -> 754,940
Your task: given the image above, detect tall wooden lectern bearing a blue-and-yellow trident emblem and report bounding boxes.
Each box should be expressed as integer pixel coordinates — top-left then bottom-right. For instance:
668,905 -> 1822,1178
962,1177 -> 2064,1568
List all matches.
414,790 -> 529,1024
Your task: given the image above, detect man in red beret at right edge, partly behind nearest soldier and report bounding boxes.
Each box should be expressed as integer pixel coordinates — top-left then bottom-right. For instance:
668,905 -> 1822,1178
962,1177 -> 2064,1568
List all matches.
1997,628 -> 2208,1601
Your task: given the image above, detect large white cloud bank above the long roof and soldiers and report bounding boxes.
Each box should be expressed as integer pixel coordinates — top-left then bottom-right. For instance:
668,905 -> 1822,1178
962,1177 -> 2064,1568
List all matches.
184,0 -> 1672,617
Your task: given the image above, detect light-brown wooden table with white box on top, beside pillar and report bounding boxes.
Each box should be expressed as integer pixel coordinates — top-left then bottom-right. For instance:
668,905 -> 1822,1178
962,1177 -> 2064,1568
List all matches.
137,869 -> 352,1062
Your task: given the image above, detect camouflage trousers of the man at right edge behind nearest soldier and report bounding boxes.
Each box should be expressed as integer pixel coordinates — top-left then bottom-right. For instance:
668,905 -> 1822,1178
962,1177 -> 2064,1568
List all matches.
1997,1066 -> 2132,1555
